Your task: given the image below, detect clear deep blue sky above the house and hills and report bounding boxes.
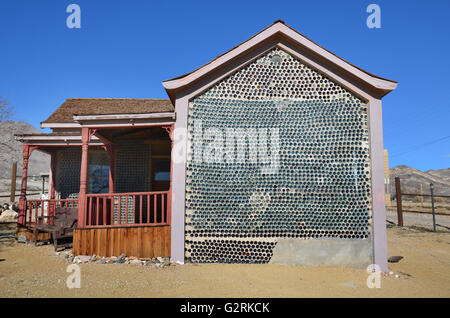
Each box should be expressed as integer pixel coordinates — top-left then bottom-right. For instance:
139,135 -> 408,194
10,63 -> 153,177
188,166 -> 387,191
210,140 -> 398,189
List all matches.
0,0 -> 450,170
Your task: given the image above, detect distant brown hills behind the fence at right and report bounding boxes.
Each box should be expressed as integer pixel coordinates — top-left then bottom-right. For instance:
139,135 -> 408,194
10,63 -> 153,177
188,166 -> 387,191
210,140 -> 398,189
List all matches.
389,165 -> 450,195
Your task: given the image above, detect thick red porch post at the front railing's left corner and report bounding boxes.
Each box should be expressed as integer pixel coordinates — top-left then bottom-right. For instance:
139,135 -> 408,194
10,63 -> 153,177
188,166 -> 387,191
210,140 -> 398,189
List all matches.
78,127 -> 90,227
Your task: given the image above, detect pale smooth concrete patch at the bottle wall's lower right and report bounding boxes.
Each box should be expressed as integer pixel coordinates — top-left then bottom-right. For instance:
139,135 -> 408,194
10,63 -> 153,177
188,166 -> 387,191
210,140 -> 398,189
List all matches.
270,239 -> 373,268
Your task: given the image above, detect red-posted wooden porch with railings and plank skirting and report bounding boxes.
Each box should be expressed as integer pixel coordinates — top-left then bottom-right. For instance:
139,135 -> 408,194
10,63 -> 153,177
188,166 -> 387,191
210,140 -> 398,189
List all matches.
18,121 -> 173,258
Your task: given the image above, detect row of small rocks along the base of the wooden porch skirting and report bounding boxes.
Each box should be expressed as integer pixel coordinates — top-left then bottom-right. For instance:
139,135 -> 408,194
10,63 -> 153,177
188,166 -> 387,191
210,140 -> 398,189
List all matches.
56,251 -> 178,268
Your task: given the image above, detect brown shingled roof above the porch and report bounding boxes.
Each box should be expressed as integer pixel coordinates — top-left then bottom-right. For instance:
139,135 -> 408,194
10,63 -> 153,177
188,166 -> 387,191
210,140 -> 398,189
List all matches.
42,98 -> 174,123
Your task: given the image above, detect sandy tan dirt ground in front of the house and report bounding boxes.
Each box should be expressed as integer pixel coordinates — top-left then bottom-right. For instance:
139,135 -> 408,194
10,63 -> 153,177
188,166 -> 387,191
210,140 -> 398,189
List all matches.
0,227 -> 450,297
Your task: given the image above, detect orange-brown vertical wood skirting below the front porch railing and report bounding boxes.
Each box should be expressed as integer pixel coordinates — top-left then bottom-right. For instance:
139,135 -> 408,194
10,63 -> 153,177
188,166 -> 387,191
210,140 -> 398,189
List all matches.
73,225 -> 170,258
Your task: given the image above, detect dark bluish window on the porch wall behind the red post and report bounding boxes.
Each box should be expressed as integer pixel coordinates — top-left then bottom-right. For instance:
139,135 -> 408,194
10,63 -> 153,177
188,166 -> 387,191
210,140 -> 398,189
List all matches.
88,151 -> 109,193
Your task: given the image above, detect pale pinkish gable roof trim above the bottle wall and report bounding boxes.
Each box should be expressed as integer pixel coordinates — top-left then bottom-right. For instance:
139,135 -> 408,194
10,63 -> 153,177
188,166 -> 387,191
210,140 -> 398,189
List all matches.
162,20 -> 397,103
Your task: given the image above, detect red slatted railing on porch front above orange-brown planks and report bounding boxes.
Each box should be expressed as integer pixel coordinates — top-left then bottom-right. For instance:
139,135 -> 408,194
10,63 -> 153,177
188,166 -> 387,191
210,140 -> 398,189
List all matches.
83,191 -> 171,228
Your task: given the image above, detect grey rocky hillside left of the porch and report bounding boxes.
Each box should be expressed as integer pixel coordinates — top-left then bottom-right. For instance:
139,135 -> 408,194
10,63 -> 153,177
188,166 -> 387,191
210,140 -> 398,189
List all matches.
0,121 -> 50,182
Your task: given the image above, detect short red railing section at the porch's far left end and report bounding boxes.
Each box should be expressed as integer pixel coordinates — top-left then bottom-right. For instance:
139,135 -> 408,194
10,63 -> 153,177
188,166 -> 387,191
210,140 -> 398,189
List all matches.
21,199 -> 78,226
